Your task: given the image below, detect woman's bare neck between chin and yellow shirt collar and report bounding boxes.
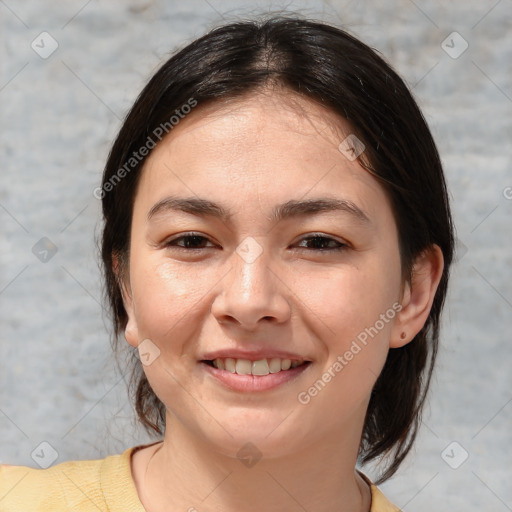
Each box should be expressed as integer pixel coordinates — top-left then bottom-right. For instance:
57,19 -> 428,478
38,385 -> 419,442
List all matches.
141,414 -> 371,512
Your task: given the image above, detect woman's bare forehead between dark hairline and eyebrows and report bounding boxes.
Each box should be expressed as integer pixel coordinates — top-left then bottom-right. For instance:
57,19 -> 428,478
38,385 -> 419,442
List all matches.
136,92 -> 389,230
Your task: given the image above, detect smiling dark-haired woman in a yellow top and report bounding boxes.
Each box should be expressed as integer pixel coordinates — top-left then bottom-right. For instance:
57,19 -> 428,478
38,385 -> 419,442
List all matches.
0,14 -> 453,512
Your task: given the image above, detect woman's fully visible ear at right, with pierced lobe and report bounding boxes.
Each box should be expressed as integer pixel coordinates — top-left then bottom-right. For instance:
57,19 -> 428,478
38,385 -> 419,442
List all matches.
389,244 -> 444,348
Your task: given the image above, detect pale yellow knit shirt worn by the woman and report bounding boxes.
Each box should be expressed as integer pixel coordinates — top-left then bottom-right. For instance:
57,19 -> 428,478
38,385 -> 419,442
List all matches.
0,445 -> 400,512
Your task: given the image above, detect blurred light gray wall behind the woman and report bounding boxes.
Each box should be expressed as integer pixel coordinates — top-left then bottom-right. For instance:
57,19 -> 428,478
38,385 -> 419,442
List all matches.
0,0 -> 512,512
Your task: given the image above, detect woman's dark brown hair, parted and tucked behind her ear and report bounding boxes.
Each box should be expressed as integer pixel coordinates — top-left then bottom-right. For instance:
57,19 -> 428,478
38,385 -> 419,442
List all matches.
101,15 -> 454,483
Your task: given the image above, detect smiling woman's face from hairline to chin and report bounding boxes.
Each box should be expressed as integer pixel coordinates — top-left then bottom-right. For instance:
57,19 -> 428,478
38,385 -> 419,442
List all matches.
125,93 -> 401,457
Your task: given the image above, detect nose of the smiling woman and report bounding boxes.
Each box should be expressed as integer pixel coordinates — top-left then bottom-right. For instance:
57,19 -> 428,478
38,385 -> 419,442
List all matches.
211,242 -> 291,331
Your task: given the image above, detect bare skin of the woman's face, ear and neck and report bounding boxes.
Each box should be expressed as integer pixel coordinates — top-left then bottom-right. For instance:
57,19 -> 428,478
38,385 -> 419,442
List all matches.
119,90 -> 443,512
